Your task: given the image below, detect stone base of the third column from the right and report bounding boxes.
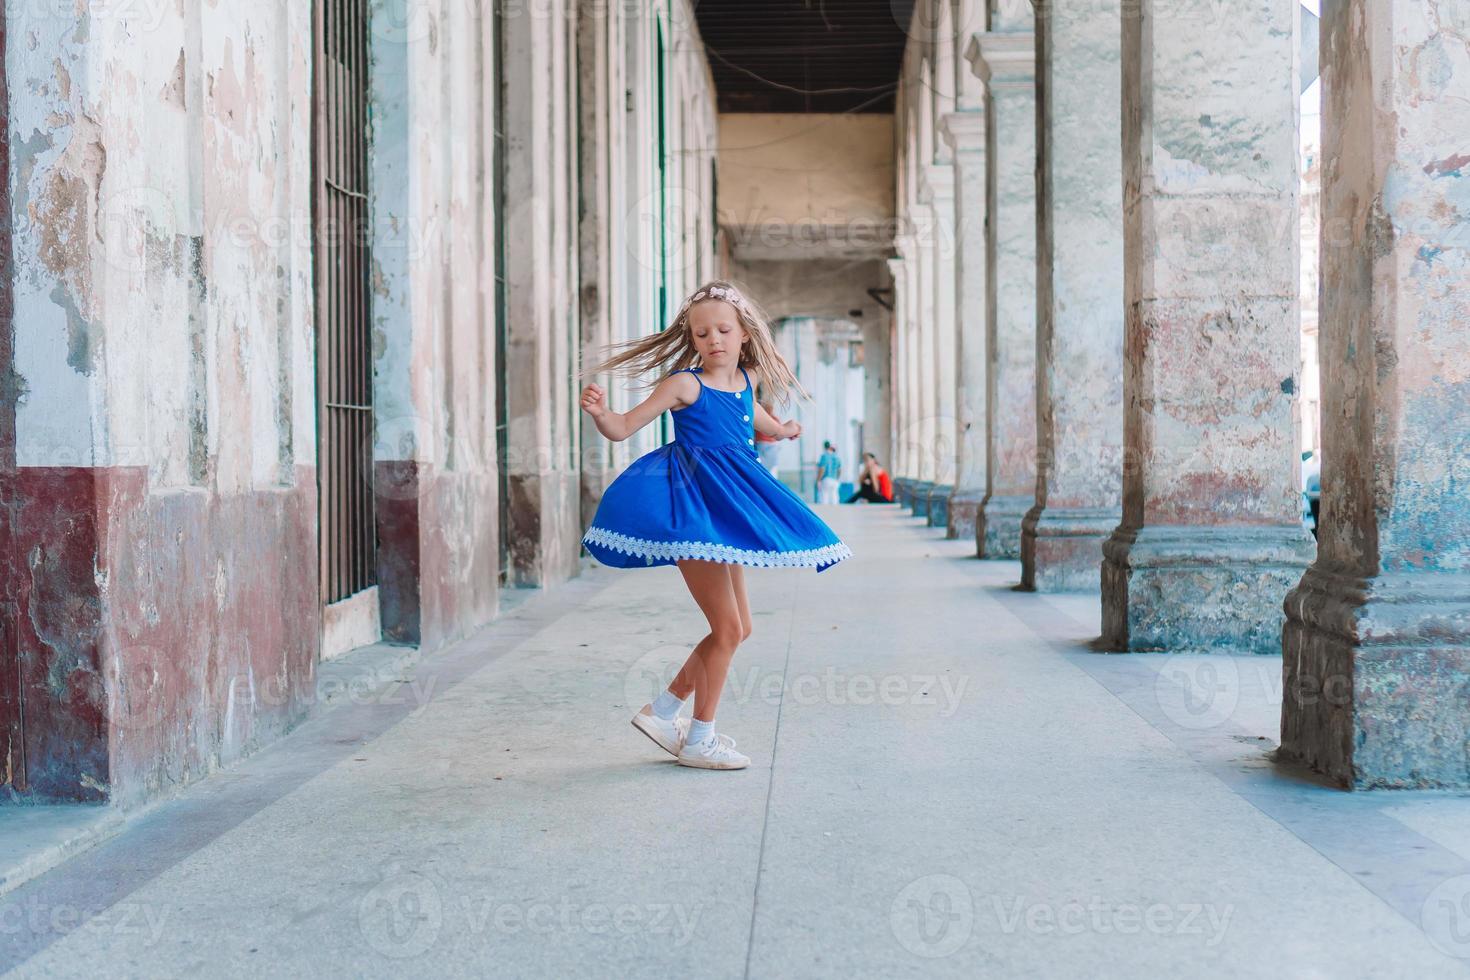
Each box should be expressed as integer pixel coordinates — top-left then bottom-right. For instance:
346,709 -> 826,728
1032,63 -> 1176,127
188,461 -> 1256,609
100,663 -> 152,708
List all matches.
1020,505 -> 1123,592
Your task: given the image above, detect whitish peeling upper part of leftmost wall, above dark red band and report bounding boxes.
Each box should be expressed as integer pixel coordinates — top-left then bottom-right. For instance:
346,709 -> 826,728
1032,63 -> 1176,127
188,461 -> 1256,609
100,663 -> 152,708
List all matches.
7,4 -> 315,481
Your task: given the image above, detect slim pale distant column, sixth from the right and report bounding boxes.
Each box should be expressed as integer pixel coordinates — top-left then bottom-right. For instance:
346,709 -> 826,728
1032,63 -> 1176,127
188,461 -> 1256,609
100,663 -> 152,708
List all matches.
926,169 -> 956,538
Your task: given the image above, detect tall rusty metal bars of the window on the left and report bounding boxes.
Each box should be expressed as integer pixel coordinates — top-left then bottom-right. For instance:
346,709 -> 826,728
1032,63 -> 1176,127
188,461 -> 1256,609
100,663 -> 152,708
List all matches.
313,0 -> 376,602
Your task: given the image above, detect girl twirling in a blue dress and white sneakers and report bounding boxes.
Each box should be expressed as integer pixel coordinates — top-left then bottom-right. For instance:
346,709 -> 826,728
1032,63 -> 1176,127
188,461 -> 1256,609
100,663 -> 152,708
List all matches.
582,281 -> 853,768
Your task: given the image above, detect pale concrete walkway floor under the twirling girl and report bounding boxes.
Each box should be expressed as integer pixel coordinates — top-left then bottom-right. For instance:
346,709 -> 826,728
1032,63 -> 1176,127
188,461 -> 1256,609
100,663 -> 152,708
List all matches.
0,507 -> 1470,977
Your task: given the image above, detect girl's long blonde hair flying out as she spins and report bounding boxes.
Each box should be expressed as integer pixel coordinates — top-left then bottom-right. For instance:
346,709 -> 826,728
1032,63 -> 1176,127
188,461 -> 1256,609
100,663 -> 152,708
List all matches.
581,279 -> 811,406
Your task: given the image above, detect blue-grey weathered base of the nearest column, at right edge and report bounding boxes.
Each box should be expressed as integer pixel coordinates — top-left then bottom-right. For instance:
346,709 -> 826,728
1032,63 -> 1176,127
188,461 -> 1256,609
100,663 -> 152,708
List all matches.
1279,567 -> 1470,789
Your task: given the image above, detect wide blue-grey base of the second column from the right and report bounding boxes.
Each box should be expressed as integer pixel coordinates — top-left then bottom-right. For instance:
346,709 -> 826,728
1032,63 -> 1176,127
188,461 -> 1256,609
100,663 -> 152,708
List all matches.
1103,525 -> 1316,654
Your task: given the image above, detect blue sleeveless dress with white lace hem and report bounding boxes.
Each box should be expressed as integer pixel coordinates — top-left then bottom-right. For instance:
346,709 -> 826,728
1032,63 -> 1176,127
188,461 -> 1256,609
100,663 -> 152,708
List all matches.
582,367 -> 853,572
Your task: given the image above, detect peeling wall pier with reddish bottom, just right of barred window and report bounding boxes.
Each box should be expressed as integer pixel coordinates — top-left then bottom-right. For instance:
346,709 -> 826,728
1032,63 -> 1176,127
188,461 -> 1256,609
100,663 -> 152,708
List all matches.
370,0 -> 500,648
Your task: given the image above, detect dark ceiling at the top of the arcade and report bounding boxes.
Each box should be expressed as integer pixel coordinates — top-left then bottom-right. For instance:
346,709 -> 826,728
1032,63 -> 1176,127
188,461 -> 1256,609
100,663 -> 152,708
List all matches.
694,0 -> 914,113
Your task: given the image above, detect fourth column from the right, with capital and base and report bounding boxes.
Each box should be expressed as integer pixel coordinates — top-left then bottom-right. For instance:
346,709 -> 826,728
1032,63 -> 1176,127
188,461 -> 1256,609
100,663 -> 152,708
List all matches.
966,26 -> 1036,558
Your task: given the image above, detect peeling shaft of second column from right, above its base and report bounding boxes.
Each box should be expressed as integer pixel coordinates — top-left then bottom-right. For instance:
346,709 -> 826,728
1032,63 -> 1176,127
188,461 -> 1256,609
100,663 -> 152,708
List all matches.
1123,0 -> 1301,526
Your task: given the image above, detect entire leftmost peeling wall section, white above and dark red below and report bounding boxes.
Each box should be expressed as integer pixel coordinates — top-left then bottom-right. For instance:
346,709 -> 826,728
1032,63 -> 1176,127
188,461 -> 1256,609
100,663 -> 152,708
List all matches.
6,3 -> 319,804
